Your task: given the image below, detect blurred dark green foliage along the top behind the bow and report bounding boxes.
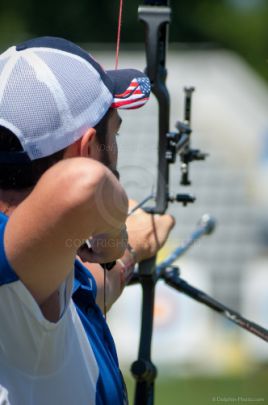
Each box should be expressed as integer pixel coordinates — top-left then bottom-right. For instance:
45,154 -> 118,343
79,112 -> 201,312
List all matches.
0,0 -> 268,80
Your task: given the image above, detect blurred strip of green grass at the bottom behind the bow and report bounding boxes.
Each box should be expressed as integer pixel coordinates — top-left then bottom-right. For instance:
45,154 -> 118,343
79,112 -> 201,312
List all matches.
126,368 -> 268,405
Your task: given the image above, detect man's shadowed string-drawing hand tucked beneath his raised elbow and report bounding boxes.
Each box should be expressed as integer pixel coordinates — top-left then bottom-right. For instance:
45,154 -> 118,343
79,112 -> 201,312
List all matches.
77,225 -> 128,263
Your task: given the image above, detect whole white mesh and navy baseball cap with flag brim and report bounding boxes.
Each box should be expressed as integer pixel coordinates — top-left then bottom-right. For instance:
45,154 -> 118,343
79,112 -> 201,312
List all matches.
0,37 -> 150,163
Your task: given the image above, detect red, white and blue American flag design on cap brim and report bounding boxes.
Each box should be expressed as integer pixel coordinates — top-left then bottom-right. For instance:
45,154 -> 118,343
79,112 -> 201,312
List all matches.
111,77 -> 151,109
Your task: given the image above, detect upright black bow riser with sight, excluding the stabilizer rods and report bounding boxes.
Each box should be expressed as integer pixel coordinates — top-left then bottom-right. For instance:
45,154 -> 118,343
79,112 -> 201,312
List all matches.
131,0 -> 200,405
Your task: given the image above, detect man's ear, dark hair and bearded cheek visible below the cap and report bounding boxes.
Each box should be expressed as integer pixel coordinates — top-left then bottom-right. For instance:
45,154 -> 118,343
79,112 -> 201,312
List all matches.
0,109 -> 121,191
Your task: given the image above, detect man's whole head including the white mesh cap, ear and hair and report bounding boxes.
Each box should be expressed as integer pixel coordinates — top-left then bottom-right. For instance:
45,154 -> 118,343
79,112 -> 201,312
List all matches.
0,37 -> 150,188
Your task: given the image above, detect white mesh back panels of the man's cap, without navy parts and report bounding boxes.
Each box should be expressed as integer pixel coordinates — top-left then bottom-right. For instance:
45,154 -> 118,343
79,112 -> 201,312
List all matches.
0,48 -> 113,159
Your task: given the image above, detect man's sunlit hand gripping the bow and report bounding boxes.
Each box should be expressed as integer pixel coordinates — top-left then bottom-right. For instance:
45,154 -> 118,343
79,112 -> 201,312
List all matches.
126,200 -> 175,262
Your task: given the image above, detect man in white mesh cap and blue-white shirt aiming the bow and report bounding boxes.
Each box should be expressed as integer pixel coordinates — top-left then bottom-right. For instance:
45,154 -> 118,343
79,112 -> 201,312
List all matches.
0,37 -> 174,405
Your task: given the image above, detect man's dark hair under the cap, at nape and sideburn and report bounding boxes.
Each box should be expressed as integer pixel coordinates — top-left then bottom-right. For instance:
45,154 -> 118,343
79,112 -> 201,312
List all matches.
0,110 -> 110,190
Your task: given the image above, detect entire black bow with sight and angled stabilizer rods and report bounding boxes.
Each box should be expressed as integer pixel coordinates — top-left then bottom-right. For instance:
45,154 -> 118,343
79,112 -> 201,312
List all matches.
127,0 -> 268,405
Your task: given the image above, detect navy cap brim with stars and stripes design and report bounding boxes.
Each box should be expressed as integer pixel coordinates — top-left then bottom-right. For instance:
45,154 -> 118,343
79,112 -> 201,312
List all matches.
106,69 -> 151,109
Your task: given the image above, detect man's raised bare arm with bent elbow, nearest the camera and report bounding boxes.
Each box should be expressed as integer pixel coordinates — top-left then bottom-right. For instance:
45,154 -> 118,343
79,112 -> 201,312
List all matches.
4,158 -> 127,304
